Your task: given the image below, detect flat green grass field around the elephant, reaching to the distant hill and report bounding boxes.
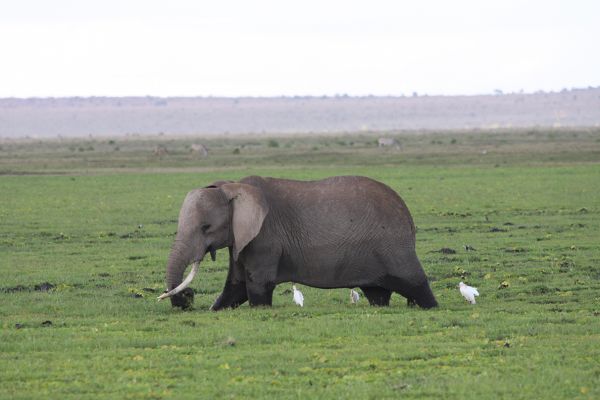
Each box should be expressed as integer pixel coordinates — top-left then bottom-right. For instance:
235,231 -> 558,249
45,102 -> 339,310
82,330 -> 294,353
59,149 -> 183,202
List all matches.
0,129 -> 600,399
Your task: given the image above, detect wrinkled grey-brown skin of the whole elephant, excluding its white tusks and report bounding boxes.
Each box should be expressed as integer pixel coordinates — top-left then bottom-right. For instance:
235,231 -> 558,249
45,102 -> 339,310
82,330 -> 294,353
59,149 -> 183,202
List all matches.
167,176 -> 437,311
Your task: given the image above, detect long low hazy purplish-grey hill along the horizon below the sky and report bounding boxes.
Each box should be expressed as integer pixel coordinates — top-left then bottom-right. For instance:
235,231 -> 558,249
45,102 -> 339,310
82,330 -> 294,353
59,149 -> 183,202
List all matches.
0,88 -> 600,138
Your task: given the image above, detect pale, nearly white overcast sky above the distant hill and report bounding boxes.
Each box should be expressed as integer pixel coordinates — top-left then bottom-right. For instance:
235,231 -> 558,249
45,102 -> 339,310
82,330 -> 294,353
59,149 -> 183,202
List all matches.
0,0 -> 600,97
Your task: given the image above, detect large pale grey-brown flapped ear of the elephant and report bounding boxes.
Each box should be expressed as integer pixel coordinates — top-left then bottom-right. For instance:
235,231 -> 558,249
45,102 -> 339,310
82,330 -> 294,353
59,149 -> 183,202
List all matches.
221,183 -> 269,260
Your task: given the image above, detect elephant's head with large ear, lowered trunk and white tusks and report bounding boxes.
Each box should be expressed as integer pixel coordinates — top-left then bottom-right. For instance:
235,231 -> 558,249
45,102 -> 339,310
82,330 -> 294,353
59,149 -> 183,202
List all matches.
159,182 -> 269,308
